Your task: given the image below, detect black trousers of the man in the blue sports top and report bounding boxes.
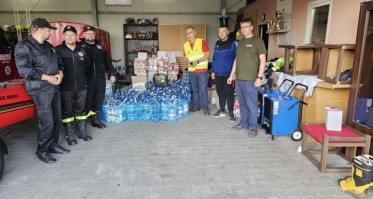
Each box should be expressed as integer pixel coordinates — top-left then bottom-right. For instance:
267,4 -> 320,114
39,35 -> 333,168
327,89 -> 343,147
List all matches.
215,75 -> 234,113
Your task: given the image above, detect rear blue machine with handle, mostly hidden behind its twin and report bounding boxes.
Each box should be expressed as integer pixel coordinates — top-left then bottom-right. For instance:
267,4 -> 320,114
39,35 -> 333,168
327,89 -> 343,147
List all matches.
258,79 -> 294,125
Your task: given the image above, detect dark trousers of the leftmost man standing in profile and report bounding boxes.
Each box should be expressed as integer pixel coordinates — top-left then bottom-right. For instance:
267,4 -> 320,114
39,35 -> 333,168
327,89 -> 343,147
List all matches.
31,92 -> 61,154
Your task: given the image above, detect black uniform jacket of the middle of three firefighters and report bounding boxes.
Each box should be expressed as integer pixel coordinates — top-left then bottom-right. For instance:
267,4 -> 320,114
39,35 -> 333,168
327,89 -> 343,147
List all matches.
56,42 -> 90,91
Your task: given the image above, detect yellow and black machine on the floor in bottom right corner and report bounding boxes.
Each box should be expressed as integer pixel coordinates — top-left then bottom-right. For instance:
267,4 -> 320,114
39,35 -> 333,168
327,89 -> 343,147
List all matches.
338,156 -> 373,198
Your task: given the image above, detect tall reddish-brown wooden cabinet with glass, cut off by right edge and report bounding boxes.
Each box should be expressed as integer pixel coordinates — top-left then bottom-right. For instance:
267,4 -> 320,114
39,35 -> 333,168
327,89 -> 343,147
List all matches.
347,1 -> 373,155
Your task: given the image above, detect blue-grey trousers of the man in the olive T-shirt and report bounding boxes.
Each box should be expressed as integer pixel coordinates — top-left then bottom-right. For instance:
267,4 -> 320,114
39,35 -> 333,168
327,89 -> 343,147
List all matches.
236,80 -> 258,129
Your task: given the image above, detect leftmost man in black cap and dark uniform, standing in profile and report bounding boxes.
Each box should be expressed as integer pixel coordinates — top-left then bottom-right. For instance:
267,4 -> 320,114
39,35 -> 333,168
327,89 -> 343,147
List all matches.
15,18 -> 70,163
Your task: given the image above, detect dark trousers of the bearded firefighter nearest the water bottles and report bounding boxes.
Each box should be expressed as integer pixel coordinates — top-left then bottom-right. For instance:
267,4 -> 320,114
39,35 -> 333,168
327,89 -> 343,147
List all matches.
85,78 -> 106,113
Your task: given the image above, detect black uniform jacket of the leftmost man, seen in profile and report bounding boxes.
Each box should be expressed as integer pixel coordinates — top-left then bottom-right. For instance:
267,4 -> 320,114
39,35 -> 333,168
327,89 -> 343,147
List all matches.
15,36 -> 63,95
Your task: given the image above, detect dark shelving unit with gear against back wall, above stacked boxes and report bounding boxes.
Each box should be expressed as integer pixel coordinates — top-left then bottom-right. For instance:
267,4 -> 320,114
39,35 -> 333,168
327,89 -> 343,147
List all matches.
123,24 -> 159,73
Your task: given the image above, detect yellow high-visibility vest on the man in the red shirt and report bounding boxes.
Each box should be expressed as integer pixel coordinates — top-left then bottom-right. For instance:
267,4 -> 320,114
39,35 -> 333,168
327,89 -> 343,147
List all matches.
184,38 -> 208,72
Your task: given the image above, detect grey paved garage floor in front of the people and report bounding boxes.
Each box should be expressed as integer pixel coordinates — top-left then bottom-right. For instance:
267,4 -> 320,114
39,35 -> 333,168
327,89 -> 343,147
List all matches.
0,109 -> 352,199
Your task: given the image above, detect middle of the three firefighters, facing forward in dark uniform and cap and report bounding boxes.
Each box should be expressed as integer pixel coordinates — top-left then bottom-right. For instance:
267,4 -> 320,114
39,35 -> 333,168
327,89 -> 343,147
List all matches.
56,25 -> 92,145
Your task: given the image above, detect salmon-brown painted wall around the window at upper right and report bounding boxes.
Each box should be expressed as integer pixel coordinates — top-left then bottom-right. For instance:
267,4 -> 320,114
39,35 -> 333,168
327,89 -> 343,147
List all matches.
243,0 -> 361,59
